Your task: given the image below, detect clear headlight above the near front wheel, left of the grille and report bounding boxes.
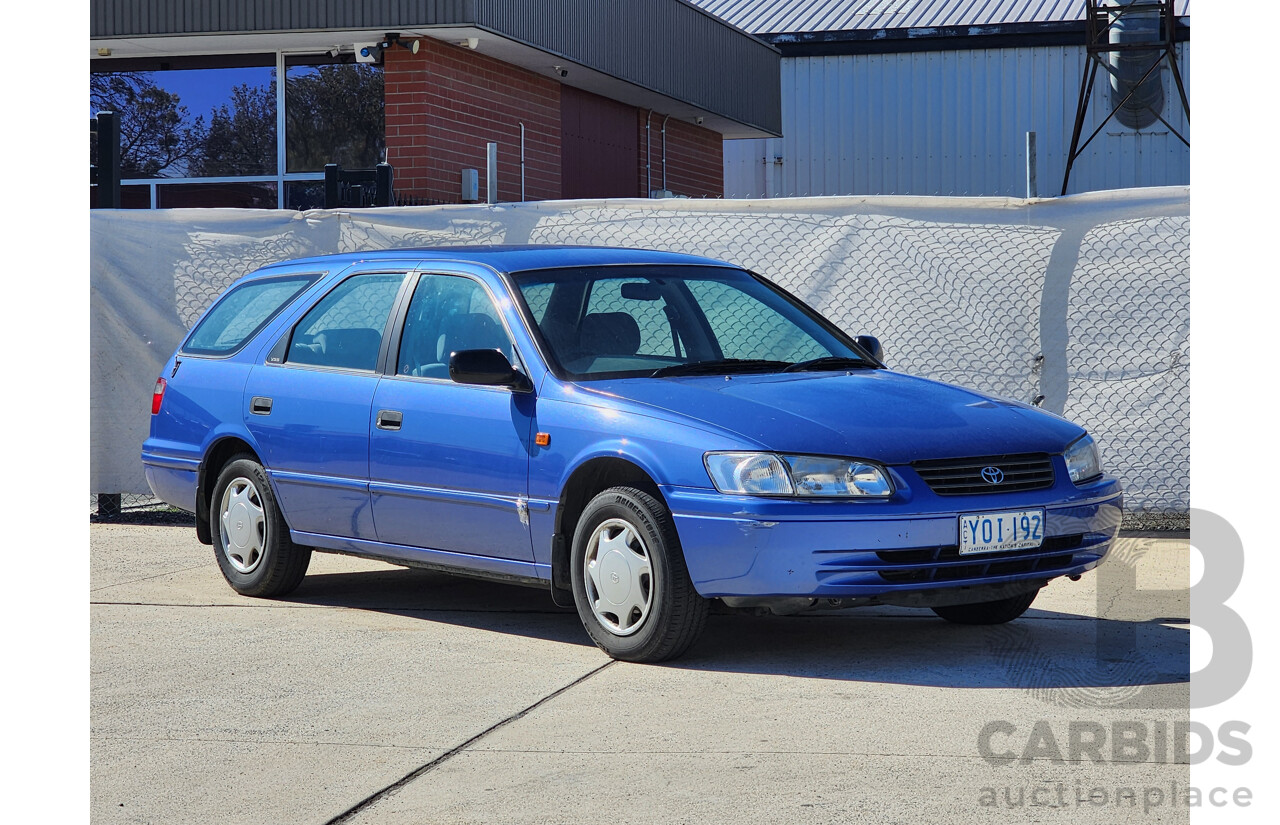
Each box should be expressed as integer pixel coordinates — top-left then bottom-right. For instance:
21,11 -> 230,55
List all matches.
705,453 -> 893,498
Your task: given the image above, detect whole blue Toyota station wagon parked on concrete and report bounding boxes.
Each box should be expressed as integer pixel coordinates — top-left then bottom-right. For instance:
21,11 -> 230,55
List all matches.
142,247 -> 1121,661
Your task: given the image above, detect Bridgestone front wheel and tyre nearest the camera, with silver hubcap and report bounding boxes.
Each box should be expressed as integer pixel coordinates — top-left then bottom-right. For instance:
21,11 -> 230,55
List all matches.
570,487 -> 708,663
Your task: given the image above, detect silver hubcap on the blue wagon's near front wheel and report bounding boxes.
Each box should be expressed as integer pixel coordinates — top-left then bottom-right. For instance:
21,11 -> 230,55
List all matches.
584,518 -> 654,636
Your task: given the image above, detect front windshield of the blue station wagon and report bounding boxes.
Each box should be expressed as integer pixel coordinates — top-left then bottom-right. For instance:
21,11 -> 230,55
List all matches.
515,266 -> 877,379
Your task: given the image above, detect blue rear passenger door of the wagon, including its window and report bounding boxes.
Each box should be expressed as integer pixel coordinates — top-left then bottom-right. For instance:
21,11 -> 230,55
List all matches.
244,269 -> 406,540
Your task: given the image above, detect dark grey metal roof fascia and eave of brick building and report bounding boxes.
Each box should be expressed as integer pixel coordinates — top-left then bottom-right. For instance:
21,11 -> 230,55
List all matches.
90,0 -> 782,138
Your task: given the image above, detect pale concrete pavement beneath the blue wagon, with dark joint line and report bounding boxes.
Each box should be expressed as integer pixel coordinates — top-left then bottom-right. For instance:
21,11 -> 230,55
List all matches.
90,524 -> 1190,825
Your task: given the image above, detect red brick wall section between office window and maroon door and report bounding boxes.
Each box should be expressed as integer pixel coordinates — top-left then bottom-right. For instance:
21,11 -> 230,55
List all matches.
384,37 -> 561,203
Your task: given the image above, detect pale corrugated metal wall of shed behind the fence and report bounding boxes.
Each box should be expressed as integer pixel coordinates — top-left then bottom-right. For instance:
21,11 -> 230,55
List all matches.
724,43 -> 1190,197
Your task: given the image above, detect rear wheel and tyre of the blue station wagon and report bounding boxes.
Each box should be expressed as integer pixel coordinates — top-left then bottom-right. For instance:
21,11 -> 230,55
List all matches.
209,454 -> 311,597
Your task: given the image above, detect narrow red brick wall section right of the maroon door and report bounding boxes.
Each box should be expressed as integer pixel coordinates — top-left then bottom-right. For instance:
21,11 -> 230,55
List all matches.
636,109 -> 724,198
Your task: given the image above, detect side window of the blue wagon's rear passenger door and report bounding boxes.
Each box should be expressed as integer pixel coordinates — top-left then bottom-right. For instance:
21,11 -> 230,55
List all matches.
287,272 -> 404,370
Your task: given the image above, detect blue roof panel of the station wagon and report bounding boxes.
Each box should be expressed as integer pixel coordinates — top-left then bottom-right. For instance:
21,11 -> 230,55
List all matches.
259,244 -> 733,274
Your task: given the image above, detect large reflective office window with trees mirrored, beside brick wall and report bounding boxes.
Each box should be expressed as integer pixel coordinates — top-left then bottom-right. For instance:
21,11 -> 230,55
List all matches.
90,54 -> 387,208
